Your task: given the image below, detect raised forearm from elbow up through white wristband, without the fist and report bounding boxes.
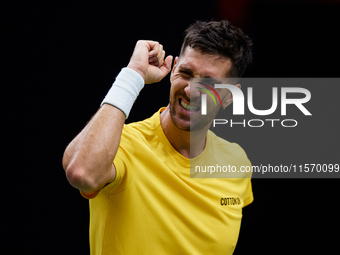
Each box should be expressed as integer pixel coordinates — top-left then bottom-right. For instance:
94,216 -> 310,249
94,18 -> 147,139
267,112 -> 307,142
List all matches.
63,68 -> 144,192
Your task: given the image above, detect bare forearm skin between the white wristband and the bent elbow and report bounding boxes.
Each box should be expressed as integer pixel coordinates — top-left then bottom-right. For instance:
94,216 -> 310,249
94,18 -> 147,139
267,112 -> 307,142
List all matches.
63,104 -> 125,192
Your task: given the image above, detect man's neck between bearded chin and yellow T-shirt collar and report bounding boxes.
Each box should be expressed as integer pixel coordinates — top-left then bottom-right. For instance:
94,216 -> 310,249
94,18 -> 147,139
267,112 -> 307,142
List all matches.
160,105 -> 209,158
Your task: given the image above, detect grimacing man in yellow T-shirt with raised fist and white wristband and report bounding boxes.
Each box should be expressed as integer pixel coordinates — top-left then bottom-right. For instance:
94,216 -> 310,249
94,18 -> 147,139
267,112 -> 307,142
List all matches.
63,21 -> 253,254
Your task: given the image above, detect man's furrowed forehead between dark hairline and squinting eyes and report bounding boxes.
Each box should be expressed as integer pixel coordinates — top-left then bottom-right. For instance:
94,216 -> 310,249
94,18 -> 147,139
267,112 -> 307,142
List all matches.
178,47 -> 232,78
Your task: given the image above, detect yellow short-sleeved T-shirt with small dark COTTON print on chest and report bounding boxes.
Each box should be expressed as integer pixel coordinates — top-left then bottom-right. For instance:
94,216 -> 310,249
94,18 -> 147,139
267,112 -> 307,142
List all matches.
82,108 -> 253,255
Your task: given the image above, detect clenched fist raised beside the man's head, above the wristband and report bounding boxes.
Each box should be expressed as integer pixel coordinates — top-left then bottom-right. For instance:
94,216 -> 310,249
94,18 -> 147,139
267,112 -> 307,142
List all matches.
127,40 -> 173,84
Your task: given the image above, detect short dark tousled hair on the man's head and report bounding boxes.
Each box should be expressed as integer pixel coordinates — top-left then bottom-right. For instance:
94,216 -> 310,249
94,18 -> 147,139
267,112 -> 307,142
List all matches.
181,20 -> 252,77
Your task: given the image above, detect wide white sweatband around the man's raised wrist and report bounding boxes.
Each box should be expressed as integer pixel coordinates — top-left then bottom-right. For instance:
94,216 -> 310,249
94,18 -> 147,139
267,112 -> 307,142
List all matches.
101,67 -> 144,118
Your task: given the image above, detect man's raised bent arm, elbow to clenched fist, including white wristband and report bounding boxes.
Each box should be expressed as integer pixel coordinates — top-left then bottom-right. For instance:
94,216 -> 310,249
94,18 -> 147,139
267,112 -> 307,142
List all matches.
62,41 -> 172,192
